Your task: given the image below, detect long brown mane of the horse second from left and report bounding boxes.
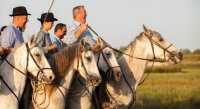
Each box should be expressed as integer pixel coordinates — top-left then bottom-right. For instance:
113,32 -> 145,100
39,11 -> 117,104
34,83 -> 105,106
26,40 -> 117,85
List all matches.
47,44 -> 81,93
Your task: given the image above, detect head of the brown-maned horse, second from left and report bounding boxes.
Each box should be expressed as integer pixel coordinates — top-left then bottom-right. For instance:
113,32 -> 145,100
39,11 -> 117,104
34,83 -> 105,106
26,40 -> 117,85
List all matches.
76,40 -> 101,86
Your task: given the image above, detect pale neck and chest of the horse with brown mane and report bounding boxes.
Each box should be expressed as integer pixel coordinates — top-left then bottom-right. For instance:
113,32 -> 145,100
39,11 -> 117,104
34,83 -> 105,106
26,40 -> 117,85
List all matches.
34,68 -> 74,109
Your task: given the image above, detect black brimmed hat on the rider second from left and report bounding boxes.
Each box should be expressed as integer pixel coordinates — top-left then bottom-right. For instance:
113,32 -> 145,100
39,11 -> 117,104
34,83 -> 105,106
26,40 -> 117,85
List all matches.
38,12 -> 58,22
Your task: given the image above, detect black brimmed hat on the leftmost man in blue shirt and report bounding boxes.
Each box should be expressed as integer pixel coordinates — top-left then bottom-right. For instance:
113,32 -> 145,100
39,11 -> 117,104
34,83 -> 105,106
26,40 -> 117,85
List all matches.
9,6 -> 31,16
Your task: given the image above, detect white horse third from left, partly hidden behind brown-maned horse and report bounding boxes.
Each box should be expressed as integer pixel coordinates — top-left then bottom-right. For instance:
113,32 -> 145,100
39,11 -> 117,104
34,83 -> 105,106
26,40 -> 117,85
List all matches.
66,38 -> 121,109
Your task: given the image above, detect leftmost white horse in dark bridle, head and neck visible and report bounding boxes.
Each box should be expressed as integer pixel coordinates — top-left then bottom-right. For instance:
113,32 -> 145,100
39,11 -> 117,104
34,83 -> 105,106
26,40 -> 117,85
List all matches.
0,37 -> 54,109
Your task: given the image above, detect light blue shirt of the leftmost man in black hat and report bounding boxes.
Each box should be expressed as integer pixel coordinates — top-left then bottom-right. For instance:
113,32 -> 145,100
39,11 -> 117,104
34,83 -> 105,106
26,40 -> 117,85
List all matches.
1,24 -> 24,48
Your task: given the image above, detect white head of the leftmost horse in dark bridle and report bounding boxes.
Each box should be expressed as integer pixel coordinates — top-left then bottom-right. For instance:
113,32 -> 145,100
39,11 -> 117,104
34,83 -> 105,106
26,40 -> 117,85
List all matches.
26,36 -> 54,83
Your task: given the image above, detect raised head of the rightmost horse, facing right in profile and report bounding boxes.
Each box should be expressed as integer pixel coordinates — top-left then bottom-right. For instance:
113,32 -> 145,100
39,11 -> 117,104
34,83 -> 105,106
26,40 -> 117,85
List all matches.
141,26 -> 183,63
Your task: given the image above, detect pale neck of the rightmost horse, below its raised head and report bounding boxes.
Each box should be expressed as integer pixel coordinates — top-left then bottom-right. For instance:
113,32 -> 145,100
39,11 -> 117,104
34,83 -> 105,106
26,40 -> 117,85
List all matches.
119,41 -> 147,89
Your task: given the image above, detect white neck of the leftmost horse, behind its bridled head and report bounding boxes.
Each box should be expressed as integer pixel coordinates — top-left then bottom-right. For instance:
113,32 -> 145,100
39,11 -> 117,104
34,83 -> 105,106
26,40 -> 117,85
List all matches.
0,47 -> 27,98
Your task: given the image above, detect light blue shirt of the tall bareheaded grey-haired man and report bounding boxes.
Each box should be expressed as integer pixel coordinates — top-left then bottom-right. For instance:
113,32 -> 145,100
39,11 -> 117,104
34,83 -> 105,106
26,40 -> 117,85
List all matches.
63,21 -> 96,45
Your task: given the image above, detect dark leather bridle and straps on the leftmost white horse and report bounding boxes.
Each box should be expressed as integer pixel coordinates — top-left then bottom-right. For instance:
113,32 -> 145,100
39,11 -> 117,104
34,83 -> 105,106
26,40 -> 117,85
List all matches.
0,43 -> 51,102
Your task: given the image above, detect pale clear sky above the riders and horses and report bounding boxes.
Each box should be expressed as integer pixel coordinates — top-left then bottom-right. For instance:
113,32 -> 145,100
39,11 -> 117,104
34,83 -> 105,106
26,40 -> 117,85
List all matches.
0,0 -> 200,50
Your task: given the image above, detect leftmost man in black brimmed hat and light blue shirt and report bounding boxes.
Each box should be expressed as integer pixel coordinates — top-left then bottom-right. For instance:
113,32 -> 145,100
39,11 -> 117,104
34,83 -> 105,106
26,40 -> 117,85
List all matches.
1,6 -> 31,51
